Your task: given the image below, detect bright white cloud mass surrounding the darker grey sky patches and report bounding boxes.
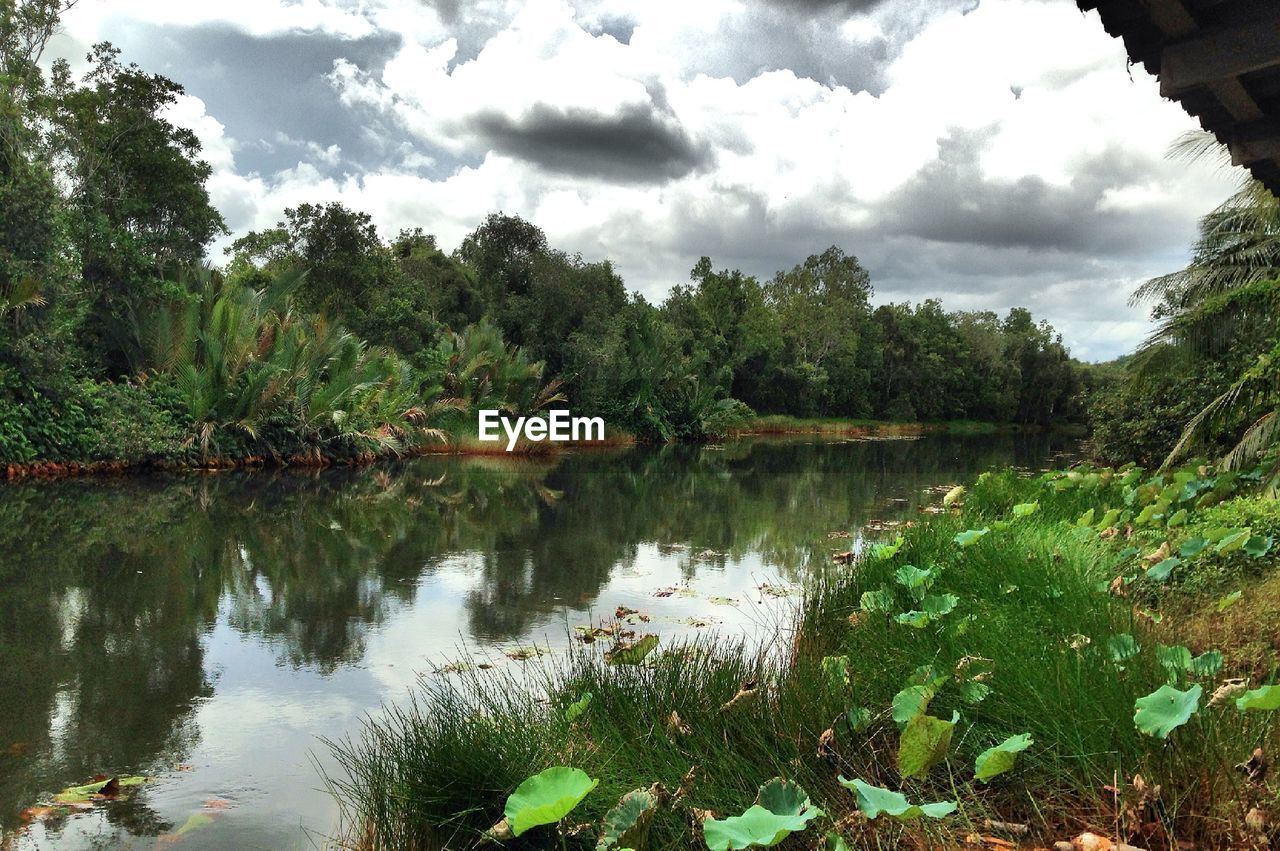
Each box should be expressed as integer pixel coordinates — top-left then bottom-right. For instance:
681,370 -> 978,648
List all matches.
72,0 -> 1236,356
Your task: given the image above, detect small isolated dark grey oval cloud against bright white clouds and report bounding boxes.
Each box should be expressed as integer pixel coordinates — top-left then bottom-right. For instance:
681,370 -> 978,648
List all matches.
471,99 -> 712,182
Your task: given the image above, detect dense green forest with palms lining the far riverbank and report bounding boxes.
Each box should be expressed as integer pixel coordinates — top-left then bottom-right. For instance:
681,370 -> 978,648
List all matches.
0,0 -> 1100,463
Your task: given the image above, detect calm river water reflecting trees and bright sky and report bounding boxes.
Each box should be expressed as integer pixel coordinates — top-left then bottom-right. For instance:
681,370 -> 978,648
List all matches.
0,436 -> 1073,848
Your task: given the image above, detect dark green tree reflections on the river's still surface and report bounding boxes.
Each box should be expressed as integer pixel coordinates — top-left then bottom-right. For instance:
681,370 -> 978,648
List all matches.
0,435 -> 1066,838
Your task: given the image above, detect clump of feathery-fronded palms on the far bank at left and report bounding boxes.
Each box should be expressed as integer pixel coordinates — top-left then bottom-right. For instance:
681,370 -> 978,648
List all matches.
133,269 -> 454,459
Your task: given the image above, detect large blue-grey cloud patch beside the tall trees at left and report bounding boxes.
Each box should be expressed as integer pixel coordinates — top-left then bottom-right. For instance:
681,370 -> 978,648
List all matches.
91,20 -> 435,173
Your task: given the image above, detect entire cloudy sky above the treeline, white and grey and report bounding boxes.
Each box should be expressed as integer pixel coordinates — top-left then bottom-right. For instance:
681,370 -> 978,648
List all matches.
49,0 -> 1239,360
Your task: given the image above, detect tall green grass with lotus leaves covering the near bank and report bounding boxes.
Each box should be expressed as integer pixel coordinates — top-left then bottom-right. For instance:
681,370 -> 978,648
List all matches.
335,467 -> 1277,848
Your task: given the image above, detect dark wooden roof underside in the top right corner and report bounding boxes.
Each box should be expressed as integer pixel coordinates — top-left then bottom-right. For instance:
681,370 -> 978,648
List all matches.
1078,0 -> 1280,196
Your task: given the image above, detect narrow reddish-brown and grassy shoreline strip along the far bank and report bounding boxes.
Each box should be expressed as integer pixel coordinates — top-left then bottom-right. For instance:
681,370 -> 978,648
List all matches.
0,416 -> 1078,481
